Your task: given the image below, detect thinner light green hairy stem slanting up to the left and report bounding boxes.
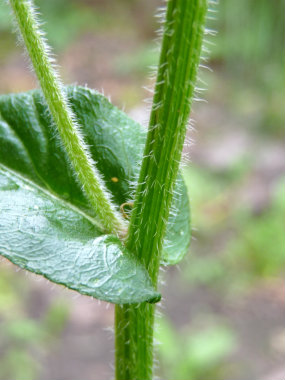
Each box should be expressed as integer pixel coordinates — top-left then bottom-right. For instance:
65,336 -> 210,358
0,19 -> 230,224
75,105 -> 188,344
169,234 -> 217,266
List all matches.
10,0 -> 126,234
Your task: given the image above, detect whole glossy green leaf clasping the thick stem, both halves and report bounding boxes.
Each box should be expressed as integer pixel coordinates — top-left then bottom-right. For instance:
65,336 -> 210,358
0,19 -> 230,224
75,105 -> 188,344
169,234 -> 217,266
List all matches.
0,87 -> 190,303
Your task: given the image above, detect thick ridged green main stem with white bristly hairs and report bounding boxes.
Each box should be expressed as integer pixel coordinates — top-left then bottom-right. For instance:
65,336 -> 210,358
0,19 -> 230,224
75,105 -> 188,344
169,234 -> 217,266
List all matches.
115,0 -> 207,380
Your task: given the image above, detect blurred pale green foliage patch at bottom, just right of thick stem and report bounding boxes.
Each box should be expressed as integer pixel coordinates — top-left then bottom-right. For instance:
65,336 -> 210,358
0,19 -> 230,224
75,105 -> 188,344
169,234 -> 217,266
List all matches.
155,318 -> 236,380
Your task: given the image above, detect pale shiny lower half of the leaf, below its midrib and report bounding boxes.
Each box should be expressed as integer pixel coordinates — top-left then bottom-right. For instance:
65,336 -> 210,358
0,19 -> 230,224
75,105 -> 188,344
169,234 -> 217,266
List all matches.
0,166 -> 160,303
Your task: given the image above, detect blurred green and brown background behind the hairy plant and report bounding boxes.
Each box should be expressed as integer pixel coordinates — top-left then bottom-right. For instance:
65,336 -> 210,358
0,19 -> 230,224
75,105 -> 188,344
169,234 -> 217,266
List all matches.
0,0 -> 285,380
